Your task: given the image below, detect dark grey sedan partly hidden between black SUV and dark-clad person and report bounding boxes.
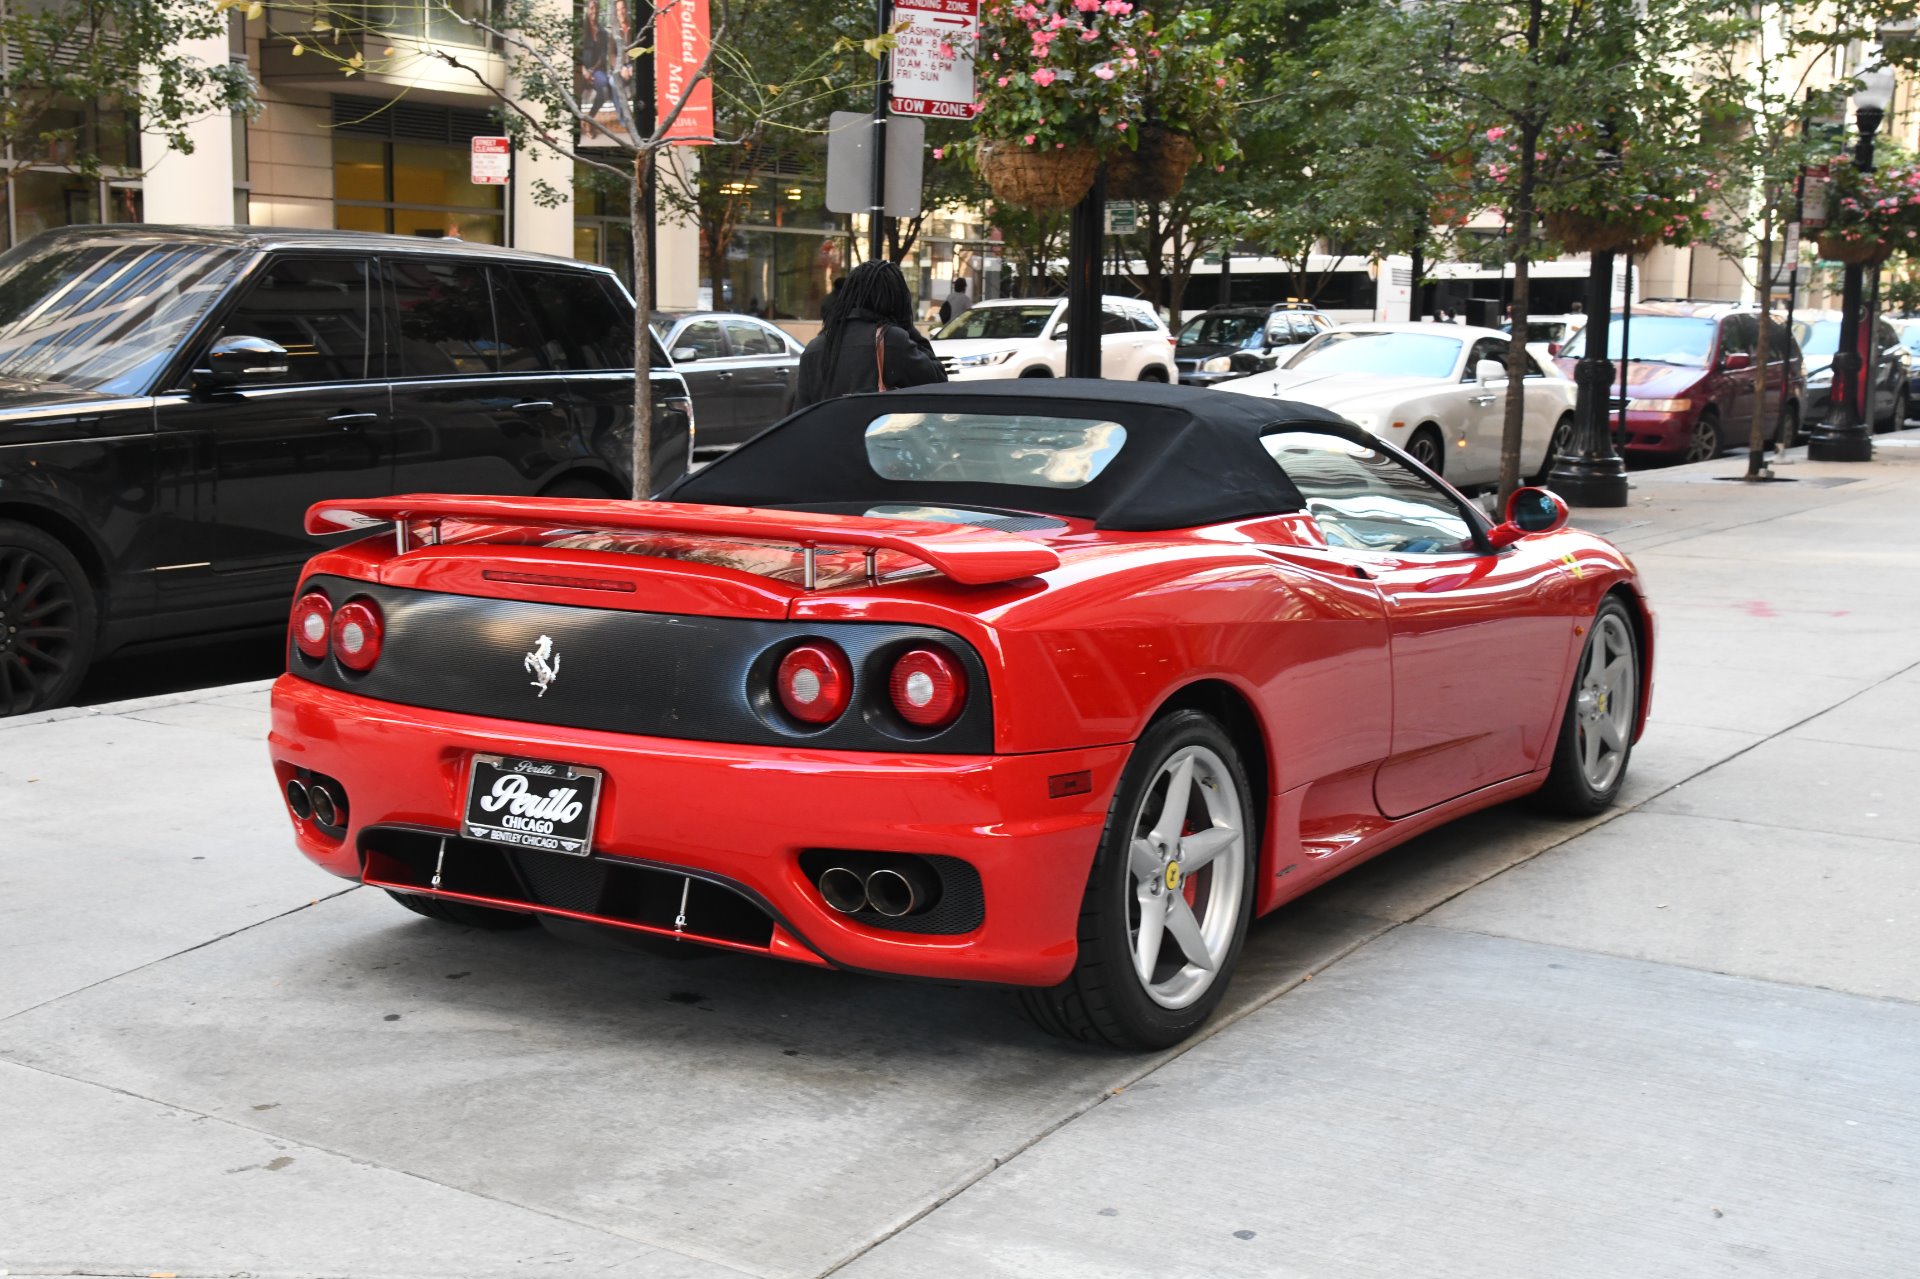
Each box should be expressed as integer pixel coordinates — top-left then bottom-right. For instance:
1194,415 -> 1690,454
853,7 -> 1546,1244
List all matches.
651,311 -> 803,449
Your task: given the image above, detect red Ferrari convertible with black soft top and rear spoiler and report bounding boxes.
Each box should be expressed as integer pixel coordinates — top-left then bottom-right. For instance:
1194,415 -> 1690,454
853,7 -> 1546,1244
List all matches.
273,380 -> 1653,1049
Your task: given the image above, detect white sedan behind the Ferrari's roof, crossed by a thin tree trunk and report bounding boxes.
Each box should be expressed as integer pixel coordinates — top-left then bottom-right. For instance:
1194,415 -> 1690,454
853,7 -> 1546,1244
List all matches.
1221,323 -> 1574,486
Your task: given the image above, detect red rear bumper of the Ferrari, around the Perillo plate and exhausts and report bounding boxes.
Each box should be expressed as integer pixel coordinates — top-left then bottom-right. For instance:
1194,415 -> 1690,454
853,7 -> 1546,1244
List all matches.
269,676 -> 1129,985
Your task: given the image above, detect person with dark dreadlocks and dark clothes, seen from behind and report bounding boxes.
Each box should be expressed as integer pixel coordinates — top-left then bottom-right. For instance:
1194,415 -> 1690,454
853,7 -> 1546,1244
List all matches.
793,261 -> 947,409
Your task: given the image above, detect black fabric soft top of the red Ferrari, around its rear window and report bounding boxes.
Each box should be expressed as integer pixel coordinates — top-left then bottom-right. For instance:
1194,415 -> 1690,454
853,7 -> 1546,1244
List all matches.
660,378 -> 1379,532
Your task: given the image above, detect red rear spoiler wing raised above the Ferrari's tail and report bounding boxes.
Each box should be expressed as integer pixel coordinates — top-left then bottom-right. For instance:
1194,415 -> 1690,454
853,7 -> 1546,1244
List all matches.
307,494 -> 1060,586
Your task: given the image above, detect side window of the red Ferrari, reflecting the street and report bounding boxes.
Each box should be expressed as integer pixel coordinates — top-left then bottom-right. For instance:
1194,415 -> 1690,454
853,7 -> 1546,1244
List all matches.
1261,430 -> 1476,555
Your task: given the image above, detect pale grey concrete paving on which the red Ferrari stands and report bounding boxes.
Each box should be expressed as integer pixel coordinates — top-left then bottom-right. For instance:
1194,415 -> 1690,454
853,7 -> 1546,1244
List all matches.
0,432 -> 1920,1279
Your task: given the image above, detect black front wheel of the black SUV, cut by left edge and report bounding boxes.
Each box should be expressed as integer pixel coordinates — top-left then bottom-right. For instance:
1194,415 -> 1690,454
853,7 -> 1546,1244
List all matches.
0,520 -> 100,716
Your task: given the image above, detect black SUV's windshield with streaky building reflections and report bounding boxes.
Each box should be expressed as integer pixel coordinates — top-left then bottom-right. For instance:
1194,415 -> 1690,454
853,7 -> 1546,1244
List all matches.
0,242 -> 240,396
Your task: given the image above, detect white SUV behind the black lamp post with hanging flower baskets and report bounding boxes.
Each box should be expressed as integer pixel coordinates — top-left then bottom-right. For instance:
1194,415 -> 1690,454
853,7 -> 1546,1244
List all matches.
933,296 -> 1173,382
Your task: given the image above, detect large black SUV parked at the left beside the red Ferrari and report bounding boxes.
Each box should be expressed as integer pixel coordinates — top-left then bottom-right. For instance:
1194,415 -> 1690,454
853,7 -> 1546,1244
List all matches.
0,225 -> 693,714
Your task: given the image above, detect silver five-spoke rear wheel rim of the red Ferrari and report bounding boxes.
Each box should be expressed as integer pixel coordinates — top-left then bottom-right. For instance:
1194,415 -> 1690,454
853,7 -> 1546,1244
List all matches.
1127,745 -> 1246,1008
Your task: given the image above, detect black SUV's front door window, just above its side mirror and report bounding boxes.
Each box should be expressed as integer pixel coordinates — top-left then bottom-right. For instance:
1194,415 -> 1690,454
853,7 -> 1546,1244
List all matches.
221,257 -> 384,382
